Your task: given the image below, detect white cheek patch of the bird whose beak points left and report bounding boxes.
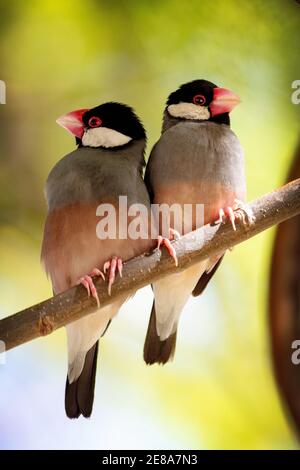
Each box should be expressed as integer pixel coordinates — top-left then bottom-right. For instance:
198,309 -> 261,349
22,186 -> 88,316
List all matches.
82,127 -> 132,148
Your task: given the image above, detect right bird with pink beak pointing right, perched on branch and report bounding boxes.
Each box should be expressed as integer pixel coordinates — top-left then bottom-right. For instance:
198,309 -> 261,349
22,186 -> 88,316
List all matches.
144,79 -> 253,364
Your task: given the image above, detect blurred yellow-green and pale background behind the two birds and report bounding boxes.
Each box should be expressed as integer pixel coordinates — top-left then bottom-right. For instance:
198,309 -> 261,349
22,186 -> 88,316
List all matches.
0,0 -> 300,449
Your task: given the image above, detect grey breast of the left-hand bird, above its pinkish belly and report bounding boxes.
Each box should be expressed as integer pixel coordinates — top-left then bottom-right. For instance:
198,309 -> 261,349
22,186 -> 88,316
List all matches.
45,142 -> 148,211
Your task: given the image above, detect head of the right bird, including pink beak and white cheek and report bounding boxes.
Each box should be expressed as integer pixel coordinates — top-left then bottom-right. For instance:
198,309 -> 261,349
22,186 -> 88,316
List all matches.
166,80 -> 240,125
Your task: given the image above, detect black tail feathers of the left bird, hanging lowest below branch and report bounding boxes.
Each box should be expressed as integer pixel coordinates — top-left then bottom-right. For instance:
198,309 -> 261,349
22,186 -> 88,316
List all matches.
65,341 -> 98,418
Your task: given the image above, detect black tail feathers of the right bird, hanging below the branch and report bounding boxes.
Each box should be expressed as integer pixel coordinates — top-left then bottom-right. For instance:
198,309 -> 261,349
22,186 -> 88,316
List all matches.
144,302 -> 177,365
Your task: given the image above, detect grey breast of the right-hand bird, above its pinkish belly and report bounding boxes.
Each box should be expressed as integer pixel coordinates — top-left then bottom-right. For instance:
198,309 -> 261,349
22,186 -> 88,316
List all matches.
147,121 -> 245,195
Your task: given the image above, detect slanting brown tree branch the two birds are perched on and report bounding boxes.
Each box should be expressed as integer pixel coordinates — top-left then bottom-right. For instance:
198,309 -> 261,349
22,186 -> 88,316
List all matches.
0,179 -> 300,350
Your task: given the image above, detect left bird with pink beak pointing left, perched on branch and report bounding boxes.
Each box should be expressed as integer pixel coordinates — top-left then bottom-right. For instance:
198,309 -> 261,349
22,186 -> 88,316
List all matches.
41,102 -> 151,418
